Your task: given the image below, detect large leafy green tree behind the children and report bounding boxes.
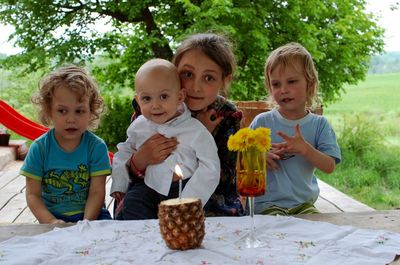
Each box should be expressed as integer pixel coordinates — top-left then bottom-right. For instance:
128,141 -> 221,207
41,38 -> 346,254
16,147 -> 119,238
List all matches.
0,0 -> 384,102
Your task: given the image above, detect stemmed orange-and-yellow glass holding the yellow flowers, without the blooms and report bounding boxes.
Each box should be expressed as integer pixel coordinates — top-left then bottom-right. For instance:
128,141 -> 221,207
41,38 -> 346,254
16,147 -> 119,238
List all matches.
236,149 -> 266,248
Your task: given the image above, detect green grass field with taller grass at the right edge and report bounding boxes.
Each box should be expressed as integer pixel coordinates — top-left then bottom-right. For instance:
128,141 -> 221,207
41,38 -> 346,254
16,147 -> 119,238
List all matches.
317,73 -> 400,209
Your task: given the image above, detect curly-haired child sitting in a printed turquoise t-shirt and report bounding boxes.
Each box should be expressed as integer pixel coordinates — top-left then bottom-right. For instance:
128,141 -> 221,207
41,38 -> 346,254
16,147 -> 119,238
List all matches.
21,66 -> 111,224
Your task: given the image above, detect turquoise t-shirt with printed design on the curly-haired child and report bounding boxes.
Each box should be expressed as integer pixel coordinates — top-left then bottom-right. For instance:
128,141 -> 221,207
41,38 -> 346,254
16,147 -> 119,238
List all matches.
20,129 -> 111,216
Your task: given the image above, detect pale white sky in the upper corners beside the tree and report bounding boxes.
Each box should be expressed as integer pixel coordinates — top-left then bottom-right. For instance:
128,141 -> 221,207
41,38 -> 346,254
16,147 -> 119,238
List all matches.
0,0 -> 400,55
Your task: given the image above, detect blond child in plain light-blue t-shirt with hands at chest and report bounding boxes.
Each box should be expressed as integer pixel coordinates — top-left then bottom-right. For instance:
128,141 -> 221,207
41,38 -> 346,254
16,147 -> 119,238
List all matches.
250,43 -> 341,215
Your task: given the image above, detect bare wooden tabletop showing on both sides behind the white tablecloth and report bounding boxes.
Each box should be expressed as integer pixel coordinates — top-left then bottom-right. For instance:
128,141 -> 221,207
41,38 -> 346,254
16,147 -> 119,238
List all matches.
0,210 -> 400,242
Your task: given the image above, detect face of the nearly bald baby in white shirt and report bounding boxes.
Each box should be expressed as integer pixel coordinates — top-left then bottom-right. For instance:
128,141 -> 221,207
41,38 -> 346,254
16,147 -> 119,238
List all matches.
135,71 -> 185,124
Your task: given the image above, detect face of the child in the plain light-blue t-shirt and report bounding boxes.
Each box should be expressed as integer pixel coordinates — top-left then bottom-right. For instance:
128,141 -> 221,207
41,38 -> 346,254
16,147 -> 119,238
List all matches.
269,62 -> 308,119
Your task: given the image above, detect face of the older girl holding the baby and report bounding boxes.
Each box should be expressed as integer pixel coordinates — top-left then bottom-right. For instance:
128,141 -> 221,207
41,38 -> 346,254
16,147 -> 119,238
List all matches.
178,49 -> 231,111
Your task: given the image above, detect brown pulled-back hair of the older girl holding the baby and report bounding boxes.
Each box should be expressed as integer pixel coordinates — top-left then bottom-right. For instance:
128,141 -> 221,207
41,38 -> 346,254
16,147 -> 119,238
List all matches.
172,33 -> 236,95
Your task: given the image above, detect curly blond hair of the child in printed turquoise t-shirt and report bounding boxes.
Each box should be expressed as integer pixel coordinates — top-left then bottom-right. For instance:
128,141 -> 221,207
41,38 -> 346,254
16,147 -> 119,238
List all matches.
32,65 -> 104,129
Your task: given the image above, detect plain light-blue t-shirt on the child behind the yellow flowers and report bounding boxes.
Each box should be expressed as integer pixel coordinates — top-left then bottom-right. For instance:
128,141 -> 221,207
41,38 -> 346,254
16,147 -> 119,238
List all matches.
250,108 -> 341,213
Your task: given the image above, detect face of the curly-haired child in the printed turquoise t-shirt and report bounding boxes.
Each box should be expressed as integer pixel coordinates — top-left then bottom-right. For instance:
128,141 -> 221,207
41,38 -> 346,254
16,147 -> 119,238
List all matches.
50,87 -> 91,147
